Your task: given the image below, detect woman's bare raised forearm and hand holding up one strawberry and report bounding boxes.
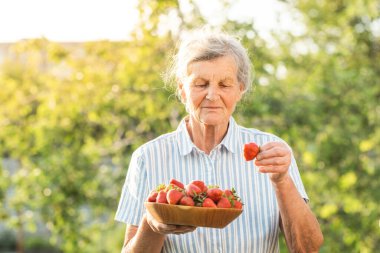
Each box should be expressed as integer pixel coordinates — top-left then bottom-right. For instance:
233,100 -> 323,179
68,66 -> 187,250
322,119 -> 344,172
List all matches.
255,142 -> 323,253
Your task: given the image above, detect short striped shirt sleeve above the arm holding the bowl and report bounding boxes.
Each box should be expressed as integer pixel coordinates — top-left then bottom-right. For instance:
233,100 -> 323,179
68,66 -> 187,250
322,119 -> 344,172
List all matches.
115,148 -> 148,226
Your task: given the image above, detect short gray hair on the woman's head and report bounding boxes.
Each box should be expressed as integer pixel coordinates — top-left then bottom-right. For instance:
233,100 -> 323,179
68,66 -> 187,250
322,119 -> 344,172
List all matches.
166,30 -> 252,95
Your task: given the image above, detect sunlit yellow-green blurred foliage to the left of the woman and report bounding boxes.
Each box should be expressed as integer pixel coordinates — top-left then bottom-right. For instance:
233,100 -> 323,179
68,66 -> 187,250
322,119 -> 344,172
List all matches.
0,31 -> 183,252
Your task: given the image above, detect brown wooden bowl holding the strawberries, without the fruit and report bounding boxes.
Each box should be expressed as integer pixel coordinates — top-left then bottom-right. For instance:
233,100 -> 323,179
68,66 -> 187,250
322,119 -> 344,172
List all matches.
144,202 -> 243,228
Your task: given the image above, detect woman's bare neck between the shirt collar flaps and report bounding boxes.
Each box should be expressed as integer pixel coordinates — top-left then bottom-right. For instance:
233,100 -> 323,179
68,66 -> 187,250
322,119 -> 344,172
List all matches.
186,117 -> 228,154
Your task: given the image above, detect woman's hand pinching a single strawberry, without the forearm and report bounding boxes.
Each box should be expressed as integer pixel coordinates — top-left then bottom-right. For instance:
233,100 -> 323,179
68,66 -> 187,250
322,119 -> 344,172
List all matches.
255,142 -> 291,183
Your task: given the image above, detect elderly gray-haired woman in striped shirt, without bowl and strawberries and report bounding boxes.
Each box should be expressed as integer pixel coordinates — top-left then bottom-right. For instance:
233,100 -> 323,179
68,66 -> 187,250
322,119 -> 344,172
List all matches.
116,32 -> 323,253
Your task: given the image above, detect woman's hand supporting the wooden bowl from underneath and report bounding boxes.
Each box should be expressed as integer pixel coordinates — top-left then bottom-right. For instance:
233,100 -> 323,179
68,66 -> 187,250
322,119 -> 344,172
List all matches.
146,211 -> 197,235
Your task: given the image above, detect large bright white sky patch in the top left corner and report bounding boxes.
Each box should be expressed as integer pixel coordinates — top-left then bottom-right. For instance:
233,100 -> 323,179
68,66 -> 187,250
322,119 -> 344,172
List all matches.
0,0 -> 138,42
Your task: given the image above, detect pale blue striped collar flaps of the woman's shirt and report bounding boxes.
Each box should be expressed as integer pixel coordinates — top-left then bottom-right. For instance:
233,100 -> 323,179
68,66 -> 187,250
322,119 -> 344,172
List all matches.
176,117 -> 239,156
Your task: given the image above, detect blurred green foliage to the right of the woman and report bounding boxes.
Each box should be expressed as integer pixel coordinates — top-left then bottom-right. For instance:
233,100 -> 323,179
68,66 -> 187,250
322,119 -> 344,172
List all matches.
242,1 -> 380,252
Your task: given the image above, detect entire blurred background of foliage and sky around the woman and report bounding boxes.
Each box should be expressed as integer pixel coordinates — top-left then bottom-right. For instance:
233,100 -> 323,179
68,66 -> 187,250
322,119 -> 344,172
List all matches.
0,0 -> 380,253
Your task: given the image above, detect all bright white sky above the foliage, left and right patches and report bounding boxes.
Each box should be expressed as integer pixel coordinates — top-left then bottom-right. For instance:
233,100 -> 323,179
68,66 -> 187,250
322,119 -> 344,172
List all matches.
0,0 -> 291,42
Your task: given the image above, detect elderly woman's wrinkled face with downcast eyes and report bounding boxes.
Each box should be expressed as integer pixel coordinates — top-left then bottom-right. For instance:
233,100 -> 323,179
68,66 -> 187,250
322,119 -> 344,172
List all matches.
179,56 -> 243,126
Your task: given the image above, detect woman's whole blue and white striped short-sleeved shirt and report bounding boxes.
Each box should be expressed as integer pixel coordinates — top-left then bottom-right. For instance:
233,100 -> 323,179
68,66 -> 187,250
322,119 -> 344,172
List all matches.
115,117 -> 308,253
